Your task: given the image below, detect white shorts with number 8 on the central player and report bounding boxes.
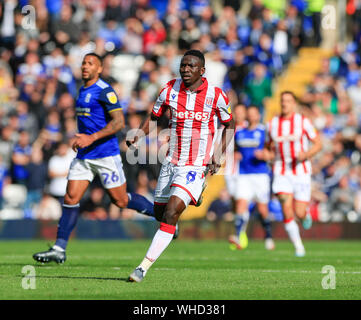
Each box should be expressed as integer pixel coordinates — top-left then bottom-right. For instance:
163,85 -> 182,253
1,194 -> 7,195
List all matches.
154,162 -> 206,206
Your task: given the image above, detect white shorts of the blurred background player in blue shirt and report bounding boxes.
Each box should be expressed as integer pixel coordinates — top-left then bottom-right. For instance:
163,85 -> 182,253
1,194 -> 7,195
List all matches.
235,173 -> 271,203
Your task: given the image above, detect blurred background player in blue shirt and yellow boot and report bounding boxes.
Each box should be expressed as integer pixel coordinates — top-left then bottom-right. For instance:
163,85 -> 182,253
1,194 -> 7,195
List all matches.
229,106 -> 275,250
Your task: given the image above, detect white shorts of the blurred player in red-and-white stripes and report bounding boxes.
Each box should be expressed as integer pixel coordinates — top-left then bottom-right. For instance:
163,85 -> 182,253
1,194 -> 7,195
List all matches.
272,175 -> 311,202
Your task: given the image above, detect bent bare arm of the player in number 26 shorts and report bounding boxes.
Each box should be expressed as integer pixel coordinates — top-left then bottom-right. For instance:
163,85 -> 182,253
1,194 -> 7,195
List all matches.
73,110 -> 125,150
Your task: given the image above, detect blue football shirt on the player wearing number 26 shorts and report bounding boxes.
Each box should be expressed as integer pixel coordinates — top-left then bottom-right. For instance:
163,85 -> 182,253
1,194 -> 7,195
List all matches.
76,79 -> 122,159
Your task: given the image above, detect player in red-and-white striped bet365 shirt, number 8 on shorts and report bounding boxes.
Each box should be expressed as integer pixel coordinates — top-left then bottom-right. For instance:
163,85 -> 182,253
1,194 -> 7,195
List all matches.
129,50 -> 234,282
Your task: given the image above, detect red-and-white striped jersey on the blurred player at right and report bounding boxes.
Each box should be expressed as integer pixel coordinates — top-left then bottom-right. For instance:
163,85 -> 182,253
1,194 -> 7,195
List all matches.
267,113 -> 317,175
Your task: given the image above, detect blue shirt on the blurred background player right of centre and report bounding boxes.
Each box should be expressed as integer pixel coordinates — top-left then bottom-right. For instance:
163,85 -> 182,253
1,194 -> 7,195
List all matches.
234,124 -> 269,174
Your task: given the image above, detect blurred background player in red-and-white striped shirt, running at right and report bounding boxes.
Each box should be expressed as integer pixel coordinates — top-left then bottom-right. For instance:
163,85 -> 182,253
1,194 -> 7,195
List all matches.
267,91 -> 322,257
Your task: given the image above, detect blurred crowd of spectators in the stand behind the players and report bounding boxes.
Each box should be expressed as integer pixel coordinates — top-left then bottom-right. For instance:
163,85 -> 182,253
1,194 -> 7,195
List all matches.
0,0 -> 361,219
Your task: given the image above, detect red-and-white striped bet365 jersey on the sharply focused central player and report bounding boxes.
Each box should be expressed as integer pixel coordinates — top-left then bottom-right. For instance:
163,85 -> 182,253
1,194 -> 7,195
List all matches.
152,78 -> 232,166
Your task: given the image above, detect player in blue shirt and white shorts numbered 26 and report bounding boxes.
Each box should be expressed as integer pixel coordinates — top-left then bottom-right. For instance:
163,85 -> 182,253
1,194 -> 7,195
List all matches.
33,53 -> 154,263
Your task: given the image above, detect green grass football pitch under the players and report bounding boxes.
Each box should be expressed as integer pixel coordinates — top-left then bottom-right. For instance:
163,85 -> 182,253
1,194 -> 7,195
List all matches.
0,239 -> 361,300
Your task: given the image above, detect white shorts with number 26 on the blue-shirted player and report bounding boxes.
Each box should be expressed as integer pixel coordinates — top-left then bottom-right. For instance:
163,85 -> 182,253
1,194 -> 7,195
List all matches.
68,155 -> 126,189
